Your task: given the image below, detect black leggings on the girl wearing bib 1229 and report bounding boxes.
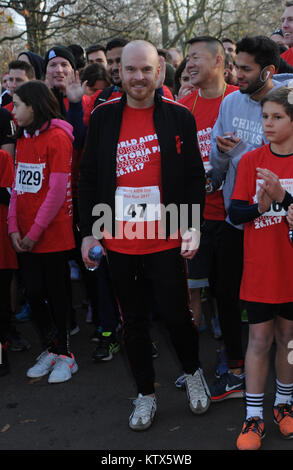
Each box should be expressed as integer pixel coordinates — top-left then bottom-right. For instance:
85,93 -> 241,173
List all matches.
19,251 -> 71,354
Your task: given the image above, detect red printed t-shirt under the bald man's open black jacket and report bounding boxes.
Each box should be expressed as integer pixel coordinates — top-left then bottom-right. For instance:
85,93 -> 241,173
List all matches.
103,105 -> 181,254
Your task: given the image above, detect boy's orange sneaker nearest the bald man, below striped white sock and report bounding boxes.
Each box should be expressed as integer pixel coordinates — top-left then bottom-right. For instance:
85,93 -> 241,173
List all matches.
236,417 -> 265,450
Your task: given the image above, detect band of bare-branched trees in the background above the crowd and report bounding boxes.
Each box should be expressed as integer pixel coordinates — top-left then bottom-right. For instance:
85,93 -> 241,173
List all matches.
0,0 -> 283,60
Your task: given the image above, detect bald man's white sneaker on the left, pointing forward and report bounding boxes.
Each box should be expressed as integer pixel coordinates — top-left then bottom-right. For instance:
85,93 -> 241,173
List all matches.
129,393 -> 157,431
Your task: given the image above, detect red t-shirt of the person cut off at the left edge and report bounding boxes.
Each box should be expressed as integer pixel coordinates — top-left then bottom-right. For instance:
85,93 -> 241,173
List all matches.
0,150 -> 18,269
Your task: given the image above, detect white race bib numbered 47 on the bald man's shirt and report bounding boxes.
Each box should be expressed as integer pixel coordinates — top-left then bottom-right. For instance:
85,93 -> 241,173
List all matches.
115,186 -> 161,222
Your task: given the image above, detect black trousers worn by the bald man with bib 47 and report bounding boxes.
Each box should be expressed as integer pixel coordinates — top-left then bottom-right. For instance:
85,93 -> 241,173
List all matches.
108,249 -> 199,395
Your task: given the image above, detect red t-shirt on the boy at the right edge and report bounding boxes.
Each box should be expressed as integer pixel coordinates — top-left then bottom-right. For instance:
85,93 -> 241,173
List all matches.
232,145 -> 293,303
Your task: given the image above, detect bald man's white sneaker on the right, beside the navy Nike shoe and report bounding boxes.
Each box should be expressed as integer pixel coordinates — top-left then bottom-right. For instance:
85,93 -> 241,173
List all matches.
185,369 -> 211,414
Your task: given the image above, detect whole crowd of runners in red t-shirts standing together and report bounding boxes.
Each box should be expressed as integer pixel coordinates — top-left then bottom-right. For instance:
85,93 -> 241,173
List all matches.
0,1 -> 293,450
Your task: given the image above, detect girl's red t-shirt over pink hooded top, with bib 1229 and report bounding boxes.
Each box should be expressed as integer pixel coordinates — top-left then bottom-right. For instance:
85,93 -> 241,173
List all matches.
8,119 -> 74,253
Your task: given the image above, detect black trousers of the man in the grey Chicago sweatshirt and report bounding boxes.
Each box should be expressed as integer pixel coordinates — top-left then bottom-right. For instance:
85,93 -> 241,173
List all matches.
217,222 -> 244,368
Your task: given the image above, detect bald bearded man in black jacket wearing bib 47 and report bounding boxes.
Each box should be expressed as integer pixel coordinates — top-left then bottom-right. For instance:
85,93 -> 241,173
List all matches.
79,41 -> 210,431
